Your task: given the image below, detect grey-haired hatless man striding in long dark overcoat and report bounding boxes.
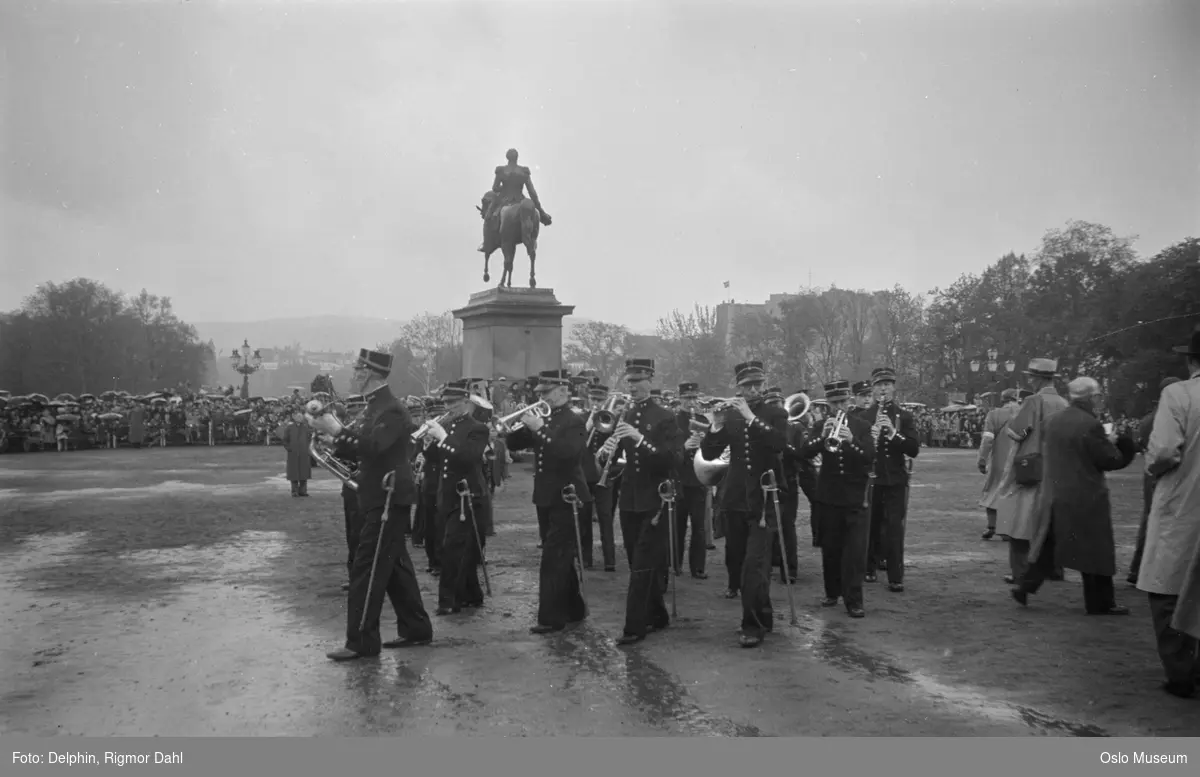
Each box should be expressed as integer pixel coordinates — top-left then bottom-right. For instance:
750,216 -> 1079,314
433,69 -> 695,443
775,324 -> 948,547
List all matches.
1013,378 -> 1138,615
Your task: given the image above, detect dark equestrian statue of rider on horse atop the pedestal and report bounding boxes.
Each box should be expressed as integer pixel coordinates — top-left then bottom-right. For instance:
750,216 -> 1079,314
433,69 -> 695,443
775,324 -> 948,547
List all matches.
475,149 -> 551,289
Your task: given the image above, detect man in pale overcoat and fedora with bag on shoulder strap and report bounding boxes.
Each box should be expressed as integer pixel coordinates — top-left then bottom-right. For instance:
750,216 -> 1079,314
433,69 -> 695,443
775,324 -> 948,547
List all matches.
996,359 -> 1068,584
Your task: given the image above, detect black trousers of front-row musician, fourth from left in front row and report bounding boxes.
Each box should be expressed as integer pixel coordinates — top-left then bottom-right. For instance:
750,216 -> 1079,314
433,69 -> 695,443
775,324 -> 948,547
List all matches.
620,510 -> 671,637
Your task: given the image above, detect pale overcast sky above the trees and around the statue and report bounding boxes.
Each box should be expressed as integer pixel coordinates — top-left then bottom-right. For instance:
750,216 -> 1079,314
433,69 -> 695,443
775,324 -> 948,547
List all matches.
0,0 -> 1200,329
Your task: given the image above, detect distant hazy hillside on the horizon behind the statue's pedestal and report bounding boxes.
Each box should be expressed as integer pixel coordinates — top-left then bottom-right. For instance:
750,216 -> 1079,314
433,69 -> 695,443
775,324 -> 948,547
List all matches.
193,315 -> 638,356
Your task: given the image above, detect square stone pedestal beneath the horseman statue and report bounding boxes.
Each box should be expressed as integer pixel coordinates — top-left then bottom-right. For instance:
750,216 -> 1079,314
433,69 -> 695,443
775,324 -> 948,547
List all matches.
454,289 -> 575,380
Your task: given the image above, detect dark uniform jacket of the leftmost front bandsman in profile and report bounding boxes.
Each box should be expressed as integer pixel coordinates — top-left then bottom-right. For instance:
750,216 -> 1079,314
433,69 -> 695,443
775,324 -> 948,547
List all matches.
336,385 -> 416,512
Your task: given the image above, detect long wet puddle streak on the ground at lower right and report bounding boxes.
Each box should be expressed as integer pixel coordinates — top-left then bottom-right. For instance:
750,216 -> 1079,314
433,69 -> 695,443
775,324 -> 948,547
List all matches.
785,615 -> 1109,736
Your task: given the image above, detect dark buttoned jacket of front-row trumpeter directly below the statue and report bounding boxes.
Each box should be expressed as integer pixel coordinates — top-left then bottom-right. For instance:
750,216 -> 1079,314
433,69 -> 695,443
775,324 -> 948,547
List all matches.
506,405 -> 592,507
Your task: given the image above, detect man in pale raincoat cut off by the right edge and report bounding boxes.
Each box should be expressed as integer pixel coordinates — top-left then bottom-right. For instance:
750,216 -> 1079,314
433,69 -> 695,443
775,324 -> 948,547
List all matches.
1138,324 -> 1200,698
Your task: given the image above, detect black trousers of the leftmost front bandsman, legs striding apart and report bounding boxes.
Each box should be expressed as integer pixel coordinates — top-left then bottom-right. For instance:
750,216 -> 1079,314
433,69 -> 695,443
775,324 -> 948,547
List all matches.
346,505 -> 433,656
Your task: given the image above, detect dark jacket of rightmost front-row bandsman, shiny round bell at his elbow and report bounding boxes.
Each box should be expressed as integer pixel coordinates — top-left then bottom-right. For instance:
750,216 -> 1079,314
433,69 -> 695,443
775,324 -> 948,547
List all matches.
700,399 -> 787,513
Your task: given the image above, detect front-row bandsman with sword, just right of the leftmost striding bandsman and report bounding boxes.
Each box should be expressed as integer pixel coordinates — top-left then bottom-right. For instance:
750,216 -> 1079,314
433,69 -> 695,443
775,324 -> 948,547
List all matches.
428,380 -> 488,615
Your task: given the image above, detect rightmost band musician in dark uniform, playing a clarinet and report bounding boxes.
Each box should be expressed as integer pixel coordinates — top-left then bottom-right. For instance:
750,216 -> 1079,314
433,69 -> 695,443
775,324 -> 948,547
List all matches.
864,367 -> 920,592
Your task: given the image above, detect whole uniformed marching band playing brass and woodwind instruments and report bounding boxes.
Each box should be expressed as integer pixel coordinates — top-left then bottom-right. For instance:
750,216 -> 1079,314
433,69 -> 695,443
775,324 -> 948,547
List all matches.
300,349 -> 919,661
